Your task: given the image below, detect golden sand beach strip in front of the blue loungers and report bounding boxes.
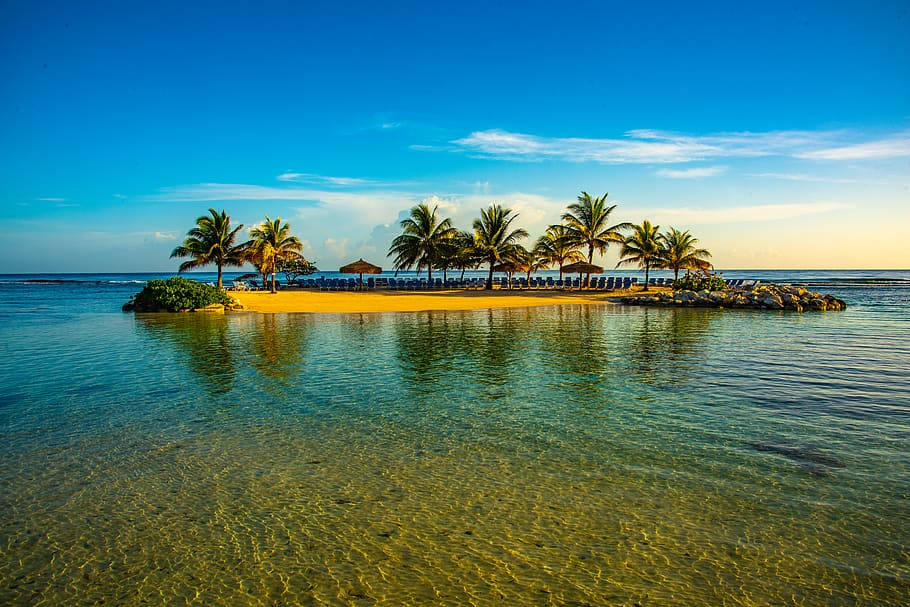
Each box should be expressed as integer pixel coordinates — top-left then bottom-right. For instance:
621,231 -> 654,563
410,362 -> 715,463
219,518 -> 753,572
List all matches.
231,289 -> 652,314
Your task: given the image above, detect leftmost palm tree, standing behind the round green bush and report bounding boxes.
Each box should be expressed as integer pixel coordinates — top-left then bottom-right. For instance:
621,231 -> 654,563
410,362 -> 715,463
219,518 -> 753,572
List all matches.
171,209 -> 250,289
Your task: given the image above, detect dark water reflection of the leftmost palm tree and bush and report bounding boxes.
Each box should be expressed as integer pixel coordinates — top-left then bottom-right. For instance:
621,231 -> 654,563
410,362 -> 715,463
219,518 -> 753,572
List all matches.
135,313 -> 237,395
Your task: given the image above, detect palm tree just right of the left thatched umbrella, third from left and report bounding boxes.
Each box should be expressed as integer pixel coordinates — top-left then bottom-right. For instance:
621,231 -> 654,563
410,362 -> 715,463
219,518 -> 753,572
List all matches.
389,202 -> 458,280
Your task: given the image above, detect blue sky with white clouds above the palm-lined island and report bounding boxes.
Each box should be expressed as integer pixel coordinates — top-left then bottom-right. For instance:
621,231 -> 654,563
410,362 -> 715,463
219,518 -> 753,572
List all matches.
0,2 -> 910,272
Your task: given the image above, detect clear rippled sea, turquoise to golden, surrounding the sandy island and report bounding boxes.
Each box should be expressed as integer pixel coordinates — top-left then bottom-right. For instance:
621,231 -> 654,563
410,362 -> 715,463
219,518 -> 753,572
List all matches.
0,270 -> 910,606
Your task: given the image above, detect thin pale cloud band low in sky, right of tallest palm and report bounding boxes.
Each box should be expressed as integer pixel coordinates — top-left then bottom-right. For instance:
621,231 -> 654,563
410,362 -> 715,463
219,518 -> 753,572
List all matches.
628,201 -> 850,225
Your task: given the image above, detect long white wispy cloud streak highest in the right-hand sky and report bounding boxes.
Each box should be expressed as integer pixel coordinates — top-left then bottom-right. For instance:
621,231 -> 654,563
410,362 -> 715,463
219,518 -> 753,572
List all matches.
444,129 -> 910,164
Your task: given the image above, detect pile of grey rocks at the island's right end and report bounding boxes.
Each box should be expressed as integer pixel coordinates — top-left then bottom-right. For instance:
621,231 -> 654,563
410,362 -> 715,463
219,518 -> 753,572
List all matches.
619,285 -> 847,312
